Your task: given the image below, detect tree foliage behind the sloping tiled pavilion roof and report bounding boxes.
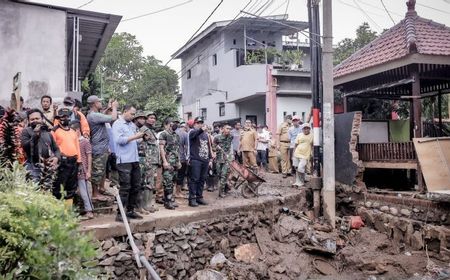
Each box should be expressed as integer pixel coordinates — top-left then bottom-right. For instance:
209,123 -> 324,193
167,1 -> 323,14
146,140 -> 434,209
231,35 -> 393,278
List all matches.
333,22 -> 378,65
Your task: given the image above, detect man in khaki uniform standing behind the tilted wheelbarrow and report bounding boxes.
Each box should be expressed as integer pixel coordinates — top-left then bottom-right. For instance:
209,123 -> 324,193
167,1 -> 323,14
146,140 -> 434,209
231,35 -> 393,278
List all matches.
239,120 -> 258,171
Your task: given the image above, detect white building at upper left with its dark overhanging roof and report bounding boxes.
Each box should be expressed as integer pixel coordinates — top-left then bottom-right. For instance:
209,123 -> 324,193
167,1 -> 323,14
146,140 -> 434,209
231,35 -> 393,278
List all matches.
0,0 -> 121,107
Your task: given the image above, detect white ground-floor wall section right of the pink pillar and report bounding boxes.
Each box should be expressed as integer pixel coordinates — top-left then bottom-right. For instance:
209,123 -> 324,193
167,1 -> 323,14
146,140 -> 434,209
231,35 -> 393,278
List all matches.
277,96 -> 312,124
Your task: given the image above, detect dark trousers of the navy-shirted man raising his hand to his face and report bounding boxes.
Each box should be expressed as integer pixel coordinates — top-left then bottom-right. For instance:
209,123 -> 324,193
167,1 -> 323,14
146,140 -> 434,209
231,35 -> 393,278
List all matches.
189,160 -> 208,201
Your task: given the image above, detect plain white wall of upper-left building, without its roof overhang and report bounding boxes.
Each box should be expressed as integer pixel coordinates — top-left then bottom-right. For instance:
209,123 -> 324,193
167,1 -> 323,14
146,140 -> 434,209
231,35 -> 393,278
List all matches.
0,1 -> 66,107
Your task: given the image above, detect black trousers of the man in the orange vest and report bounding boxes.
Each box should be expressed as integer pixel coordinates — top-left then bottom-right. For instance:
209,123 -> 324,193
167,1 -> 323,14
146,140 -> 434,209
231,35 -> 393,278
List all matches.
52,156 -> 78,199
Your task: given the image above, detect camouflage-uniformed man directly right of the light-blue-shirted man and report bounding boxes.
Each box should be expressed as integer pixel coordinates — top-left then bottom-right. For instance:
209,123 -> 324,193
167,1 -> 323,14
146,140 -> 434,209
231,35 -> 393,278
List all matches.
138,112 -> 159,213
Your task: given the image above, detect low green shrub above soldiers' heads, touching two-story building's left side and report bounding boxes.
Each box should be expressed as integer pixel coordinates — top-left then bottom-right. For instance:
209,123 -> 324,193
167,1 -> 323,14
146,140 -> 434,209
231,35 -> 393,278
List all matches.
145,92 -> 178,127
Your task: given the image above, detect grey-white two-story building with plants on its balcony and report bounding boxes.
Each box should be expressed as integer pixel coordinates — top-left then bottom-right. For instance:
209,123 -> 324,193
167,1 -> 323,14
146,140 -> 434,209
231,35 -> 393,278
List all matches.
172,16 -> 311,130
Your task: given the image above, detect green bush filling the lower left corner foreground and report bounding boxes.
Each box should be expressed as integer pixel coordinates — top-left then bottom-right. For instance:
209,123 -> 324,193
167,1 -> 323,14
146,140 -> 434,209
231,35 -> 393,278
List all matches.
0,162 -> 96,279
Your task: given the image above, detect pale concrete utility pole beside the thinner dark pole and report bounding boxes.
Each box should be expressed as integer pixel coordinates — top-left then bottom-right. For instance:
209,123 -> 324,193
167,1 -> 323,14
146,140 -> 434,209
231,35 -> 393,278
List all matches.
322,0 -> 336,225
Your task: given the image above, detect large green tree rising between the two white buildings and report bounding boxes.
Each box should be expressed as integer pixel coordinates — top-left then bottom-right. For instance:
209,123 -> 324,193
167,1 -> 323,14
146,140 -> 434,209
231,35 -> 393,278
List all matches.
82,33 -> 178,110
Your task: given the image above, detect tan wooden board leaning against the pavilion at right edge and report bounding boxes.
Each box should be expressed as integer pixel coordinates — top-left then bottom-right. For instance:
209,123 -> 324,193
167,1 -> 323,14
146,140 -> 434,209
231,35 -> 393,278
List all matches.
413,137 -> 450,192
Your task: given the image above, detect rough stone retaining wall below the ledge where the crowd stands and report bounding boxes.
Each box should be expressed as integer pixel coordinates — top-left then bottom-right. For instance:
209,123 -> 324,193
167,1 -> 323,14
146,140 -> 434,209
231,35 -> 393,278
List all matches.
99,208 -> 279,279
